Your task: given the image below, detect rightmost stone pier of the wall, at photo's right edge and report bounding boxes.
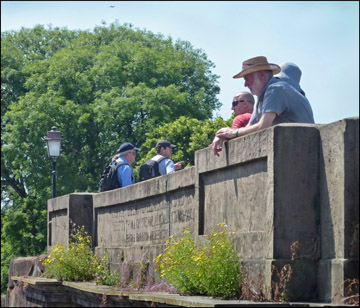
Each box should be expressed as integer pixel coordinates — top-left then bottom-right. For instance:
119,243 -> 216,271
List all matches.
319,118 -> 359,301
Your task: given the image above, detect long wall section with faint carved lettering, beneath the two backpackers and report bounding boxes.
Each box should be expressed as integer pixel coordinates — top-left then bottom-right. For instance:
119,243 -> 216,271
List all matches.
93,167 -> 196,276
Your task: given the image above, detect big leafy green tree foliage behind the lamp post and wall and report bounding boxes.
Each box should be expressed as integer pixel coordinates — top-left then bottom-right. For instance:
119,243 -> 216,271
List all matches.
1,23 -> 224,290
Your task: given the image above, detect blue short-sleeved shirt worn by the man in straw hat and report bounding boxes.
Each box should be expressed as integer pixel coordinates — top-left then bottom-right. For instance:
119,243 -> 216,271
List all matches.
250,77 -> 314,125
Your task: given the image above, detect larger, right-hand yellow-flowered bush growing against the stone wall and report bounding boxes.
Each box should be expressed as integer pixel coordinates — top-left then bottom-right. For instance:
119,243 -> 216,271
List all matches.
154,223 -> 242,299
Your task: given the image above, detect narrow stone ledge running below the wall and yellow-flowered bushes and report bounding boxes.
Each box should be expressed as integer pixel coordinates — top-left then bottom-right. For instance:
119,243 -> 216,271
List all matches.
11,276 -> 339,307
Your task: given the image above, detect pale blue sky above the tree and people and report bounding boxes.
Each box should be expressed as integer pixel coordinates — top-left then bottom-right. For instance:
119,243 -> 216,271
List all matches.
1,1 -> 359,123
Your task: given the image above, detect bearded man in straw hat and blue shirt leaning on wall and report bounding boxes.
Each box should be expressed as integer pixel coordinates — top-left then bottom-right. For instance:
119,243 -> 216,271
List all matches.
216,56 -> 314,150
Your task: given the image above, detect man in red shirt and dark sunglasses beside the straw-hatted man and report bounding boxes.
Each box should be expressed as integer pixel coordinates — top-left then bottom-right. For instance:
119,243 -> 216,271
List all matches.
209,91 -> 255,156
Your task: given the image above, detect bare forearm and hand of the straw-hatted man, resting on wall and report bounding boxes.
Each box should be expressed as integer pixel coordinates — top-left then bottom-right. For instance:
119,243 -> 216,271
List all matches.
215,112 -> 276,139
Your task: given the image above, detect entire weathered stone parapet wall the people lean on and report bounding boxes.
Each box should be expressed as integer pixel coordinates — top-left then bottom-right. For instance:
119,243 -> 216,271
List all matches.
42,118 -> 359,302
